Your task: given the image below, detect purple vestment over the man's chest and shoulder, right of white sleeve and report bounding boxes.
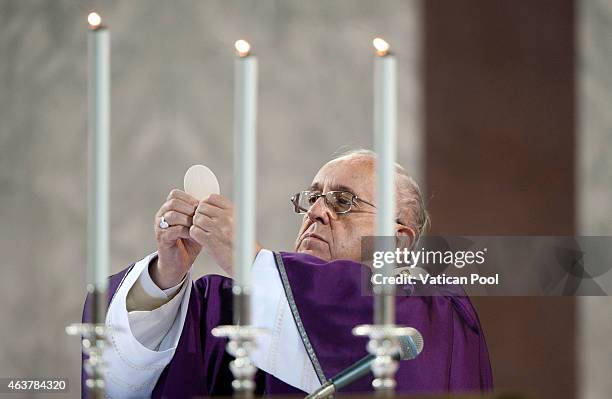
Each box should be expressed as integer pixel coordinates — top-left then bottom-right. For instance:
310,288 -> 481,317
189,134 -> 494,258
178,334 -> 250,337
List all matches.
277,253 -> 493,393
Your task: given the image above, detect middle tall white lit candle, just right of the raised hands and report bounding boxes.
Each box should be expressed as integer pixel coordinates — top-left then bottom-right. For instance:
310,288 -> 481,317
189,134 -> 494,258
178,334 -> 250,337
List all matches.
234,40 -> 257,293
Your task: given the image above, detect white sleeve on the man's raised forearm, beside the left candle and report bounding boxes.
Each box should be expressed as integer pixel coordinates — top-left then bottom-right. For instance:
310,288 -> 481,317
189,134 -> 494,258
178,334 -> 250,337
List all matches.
104,253 -> 191,398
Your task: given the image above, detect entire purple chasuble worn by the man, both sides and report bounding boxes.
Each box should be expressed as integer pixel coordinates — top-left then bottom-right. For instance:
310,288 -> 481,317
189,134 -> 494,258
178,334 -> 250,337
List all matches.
82,252 -> 493,398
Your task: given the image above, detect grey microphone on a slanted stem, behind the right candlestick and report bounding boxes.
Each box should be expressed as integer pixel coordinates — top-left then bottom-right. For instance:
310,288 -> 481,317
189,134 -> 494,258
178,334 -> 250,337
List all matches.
305,328 -> 423,399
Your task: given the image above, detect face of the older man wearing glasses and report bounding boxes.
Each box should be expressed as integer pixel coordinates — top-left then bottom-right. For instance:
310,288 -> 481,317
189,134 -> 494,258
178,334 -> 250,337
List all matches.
295,157 -> 376,262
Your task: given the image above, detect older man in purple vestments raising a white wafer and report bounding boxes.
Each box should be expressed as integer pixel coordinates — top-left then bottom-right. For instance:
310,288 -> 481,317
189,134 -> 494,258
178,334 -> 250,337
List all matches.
84,150 -> 492,397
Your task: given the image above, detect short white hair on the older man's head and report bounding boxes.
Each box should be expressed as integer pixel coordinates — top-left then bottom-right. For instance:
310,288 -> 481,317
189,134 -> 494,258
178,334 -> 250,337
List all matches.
332,149 -> 431,243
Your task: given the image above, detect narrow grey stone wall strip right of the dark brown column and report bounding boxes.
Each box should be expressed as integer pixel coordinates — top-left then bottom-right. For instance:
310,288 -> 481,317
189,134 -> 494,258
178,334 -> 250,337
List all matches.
576,0 -> 612,399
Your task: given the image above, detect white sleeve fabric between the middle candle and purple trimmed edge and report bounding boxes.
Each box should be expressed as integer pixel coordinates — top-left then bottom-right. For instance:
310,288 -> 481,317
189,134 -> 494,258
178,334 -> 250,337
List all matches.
251,249 -> 321,393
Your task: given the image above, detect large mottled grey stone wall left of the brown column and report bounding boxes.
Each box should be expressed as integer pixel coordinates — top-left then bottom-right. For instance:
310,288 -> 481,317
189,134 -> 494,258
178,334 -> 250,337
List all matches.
0,0 -> 421,397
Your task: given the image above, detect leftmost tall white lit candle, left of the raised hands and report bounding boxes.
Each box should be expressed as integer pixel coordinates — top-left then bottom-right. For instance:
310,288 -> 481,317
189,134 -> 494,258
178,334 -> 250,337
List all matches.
87,13 -> 110,292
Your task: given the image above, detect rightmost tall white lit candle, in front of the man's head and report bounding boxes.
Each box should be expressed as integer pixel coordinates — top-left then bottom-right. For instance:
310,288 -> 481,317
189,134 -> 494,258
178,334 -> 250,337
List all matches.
373,38 -> 397,324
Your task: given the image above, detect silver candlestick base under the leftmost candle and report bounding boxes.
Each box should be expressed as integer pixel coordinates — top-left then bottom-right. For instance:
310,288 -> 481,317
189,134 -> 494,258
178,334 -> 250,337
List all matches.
66,323 -> 106,399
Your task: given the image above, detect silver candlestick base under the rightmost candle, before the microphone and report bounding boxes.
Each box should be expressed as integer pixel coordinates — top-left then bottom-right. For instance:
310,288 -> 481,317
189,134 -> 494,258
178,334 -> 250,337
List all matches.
353,324 -> 413,397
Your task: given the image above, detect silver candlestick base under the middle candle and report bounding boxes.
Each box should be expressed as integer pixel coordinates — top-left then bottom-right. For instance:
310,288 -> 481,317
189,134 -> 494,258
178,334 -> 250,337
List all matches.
212,325 -> 264,398
